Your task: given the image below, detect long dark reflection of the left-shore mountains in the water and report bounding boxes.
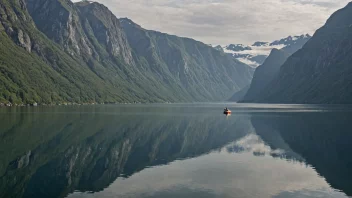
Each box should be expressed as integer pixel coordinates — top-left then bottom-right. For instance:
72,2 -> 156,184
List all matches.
0,106 -> 250,197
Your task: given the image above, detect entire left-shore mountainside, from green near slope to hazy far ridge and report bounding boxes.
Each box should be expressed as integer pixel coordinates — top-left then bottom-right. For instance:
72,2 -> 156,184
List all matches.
0,0 -> 253,104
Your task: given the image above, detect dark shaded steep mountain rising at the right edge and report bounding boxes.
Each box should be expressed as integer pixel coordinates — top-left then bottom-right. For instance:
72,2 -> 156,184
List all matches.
255,3 -> 352,103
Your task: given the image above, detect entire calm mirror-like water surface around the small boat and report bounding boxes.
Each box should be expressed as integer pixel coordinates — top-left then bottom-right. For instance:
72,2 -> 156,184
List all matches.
0,104 -> 352,198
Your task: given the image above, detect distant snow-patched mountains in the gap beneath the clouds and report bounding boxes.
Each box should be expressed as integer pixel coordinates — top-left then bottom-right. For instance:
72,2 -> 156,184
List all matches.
215,34 -> 311,67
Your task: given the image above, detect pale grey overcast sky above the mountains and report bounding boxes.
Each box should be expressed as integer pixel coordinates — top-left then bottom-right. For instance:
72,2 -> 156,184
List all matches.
76,0 -> 350,45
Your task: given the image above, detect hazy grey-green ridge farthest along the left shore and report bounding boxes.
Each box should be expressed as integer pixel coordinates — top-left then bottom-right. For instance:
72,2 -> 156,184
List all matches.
120,18 -> 253,101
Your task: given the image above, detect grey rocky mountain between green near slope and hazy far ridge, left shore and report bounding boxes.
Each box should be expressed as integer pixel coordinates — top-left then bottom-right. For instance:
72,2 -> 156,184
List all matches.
26,0 -> 180,102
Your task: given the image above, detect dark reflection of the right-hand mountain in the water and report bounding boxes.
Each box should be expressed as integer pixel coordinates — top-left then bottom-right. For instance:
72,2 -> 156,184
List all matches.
251,112 -> 352,196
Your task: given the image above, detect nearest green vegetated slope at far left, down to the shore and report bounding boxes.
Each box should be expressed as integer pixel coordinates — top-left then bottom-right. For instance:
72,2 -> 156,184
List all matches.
0,1 -> 165,103
